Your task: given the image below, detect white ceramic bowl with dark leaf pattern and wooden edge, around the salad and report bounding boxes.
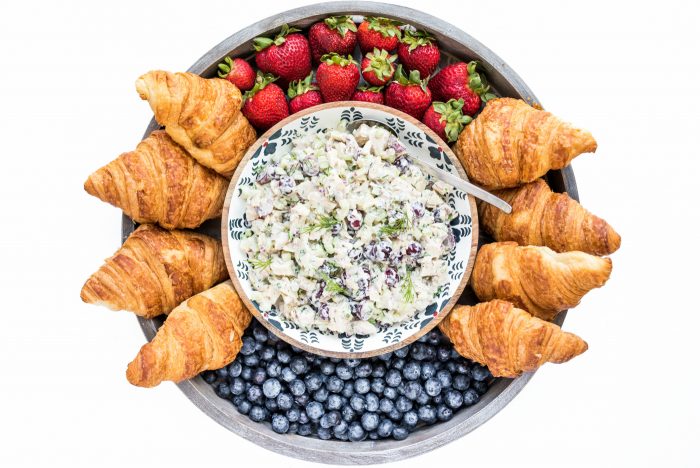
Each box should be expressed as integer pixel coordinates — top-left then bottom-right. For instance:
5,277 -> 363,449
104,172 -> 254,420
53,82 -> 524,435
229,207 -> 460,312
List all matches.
221,101 -> 478,358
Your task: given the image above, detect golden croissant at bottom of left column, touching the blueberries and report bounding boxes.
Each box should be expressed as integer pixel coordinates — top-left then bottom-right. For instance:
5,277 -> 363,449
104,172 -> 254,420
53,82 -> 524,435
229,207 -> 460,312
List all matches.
126,281 -> 252,387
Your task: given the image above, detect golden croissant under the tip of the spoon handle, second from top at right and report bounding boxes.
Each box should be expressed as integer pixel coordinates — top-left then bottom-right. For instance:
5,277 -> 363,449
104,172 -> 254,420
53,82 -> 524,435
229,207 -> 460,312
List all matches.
478,179 -> 620,255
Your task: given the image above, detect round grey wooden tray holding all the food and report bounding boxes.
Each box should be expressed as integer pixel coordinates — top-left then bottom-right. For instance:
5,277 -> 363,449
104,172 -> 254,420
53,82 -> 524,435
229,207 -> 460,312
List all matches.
122,1 -> 578,465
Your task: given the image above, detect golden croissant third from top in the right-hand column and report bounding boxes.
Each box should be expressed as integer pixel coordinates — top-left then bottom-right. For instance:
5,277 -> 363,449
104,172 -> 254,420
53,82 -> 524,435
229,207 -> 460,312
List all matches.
471,242 -> 612,320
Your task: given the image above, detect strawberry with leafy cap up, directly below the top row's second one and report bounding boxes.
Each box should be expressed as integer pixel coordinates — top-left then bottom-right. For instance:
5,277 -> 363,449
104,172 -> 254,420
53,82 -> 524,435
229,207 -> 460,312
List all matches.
316,53 -> 360,102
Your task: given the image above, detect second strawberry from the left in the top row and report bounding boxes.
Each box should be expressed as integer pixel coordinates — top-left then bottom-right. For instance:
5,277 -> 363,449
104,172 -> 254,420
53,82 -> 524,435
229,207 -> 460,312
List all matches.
309,16 -> 357,63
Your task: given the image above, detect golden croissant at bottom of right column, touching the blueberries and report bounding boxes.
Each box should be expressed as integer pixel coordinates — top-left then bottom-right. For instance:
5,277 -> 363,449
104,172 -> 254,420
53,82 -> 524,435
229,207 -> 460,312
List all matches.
440,299 -> 588,377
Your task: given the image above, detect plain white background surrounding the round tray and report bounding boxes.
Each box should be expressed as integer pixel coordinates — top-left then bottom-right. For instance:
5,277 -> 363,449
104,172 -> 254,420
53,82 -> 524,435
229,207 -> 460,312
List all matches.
0,0 -> 700,467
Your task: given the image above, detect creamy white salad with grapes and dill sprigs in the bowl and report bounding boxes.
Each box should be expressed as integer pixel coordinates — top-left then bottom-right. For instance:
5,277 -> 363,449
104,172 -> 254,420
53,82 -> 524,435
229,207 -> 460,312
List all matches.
240,125 -> 456,335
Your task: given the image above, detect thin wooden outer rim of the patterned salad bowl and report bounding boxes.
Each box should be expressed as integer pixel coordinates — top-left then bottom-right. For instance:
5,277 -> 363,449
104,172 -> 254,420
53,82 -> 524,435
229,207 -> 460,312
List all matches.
221,101 -> 479,359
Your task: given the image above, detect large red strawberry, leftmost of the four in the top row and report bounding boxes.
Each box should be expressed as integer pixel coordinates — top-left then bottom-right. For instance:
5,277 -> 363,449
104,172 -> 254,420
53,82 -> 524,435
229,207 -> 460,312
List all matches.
253,24 -> 311,87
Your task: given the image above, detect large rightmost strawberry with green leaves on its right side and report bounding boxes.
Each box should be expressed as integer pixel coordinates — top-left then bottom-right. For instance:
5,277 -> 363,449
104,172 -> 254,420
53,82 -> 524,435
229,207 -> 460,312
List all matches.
428,62 -> 496,116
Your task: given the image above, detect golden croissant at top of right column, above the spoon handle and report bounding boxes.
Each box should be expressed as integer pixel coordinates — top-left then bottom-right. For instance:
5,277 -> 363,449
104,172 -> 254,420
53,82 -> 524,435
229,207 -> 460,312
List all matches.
454,98 -> 597,189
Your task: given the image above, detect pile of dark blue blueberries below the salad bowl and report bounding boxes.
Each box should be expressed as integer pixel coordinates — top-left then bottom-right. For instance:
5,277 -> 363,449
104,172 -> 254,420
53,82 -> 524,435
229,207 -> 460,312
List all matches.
202,321 -> 493,441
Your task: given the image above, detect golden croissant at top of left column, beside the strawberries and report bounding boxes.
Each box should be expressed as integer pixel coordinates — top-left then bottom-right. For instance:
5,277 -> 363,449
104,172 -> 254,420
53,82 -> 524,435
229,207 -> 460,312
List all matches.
136,71 -> 256,177
